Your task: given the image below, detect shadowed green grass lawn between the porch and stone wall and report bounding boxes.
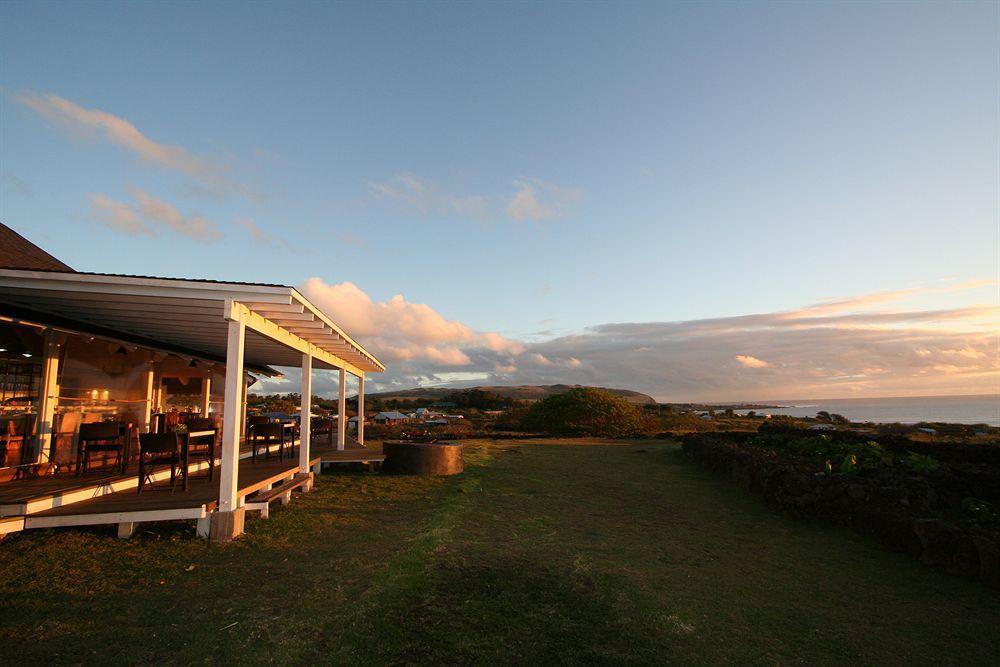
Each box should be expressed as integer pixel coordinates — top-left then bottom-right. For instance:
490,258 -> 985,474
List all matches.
0,441 -> 1000,665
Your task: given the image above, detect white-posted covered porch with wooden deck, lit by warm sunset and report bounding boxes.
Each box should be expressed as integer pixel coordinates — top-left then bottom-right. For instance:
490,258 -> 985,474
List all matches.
0,269 -> 384,540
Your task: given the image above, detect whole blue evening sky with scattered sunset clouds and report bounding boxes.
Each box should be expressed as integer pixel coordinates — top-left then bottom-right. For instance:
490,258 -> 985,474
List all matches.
0,2 -> 1000,401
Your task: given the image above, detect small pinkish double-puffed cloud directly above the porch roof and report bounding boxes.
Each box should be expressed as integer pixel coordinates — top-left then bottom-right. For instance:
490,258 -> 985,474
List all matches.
88,188 -> 222,241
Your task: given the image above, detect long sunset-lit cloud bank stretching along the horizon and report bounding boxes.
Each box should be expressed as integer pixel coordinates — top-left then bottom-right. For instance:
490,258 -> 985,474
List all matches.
260,278 -> 1000,401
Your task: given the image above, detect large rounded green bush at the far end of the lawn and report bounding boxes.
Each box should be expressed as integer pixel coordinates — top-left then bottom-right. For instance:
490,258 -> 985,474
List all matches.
523,387 -> 643,438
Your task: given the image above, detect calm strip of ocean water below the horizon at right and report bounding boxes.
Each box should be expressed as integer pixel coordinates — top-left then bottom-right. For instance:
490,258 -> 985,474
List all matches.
737,394 -> 1000,426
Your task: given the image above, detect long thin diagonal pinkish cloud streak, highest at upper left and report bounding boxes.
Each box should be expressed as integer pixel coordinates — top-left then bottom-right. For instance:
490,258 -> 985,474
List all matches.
17,91 -> 250,200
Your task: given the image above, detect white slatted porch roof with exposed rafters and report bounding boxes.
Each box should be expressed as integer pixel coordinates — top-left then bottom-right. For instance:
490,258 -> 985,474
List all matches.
0,268 -> 385,375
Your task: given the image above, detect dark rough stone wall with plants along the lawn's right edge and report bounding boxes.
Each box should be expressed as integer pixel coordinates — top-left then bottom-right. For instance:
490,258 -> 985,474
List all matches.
682,433 -> 1000,588
